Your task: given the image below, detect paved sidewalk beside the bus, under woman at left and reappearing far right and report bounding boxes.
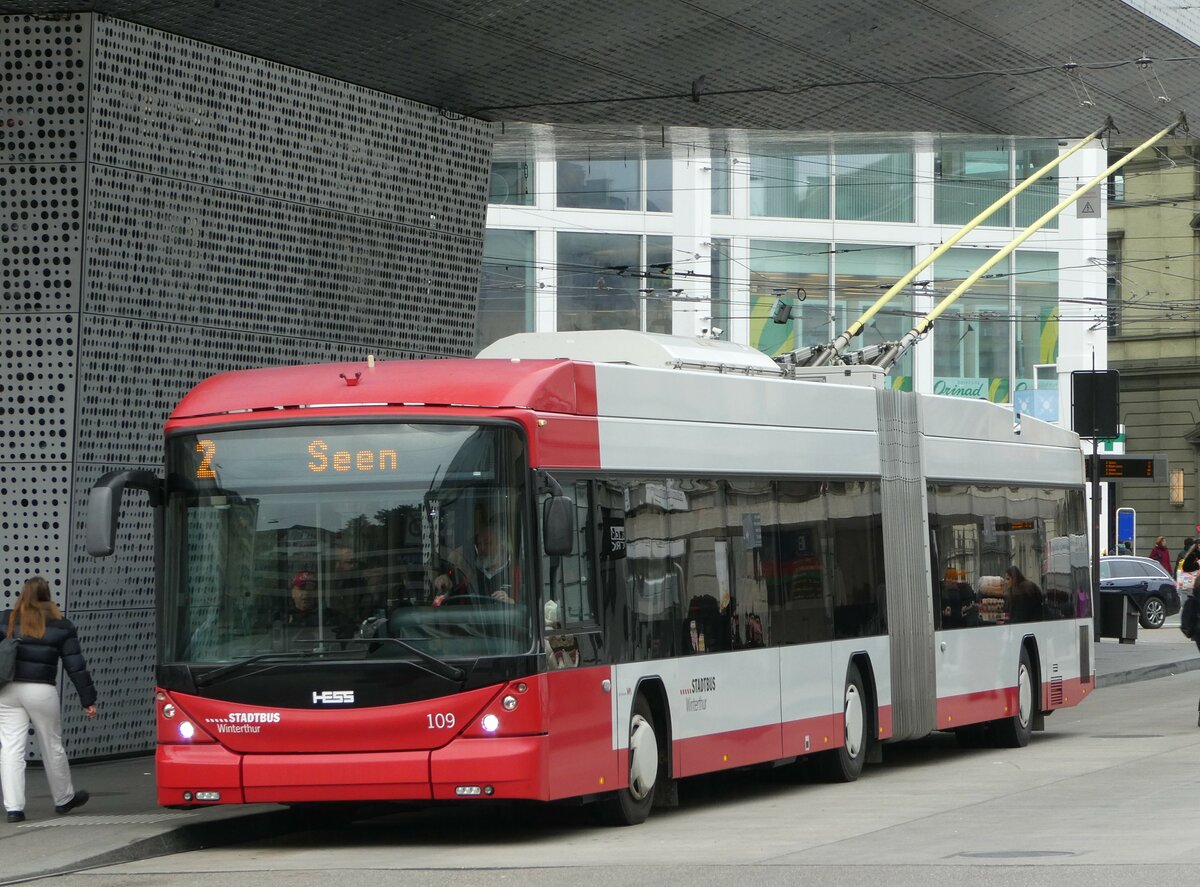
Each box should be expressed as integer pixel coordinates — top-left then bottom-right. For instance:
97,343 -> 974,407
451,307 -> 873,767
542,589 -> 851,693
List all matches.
0,623 -> 1200,886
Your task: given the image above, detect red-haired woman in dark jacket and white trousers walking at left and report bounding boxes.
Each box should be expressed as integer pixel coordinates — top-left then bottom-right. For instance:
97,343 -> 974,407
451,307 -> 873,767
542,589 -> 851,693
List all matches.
0,576 -> 96,822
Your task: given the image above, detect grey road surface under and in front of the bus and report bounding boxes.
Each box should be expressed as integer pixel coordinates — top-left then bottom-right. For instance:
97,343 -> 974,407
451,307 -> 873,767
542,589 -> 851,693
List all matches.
35,672 -> 1200,887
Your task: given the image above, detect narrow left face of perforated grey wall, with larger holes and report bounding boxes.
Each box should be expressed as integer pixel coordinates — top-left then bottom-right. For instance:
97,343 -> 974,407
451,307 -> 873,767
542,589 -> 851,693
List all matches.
0,17 -> 90,609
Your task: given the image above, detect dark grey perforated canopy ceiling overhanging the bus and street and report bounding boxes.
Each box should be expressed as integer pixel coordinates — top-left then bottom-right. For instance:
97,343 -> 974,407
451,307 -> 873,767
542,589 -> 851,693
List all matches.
9,0 -> 1200,138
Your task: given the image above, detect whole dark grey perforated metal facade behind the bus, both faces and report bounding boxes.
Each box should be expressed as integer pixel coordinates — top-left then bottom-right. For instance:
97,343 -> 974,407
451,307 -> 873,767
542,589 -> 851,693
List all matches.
0,16 -> 491,759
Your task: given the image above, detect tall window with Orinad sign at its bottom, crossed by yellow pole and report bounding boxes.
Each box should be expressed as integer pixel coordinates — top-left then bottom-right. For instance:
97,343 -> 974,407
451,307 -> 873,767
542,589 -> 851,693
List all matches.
934,248 -> 1013,403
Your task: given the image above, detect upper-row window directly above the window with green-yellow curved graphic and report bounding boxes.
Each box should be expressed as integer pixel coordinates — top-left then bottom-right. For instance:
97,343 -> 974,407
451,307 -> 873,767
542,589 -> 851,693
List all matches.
750,142 -> 830,218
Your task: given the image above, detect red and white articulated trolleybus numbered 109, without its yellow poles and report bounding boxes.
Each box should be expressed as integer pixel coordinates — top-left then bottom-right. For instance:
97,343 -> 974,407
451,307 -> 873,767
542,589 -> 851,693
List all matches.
89,331 -> 1094,823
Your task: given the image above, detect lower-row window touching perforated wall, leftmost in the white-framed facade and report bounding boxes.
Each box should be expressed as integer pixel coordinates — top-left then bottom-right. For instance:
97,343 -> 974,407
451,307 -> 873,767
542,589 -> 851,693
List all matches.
475,228 -> 536,350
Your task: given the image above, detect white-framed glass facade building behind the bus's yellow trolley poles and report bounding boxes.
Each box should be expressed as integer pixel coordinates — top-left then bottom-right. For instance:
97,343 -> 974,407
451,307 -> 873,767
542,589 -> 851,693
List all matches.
476,127 -> 1105,421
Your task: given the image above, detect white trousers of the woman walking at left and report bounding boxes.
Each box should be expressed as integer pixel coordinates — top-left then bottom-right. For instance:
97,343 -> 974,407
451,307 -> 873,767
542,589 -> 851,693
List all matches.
0,681 -> 74,810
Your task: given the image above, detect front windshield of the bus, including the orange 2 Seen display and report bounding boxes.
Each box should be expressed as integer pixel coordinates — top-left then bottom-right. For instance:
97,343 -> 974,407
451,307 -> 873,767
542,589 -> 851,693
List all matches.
160,422 -> 534,664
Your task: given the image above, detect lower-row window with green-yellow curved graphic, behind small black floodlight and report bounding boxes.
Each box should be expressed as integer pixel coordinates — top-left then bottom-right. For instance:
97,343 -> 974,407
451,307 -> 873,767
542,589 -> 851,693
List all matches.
749,240 -> 838,356
